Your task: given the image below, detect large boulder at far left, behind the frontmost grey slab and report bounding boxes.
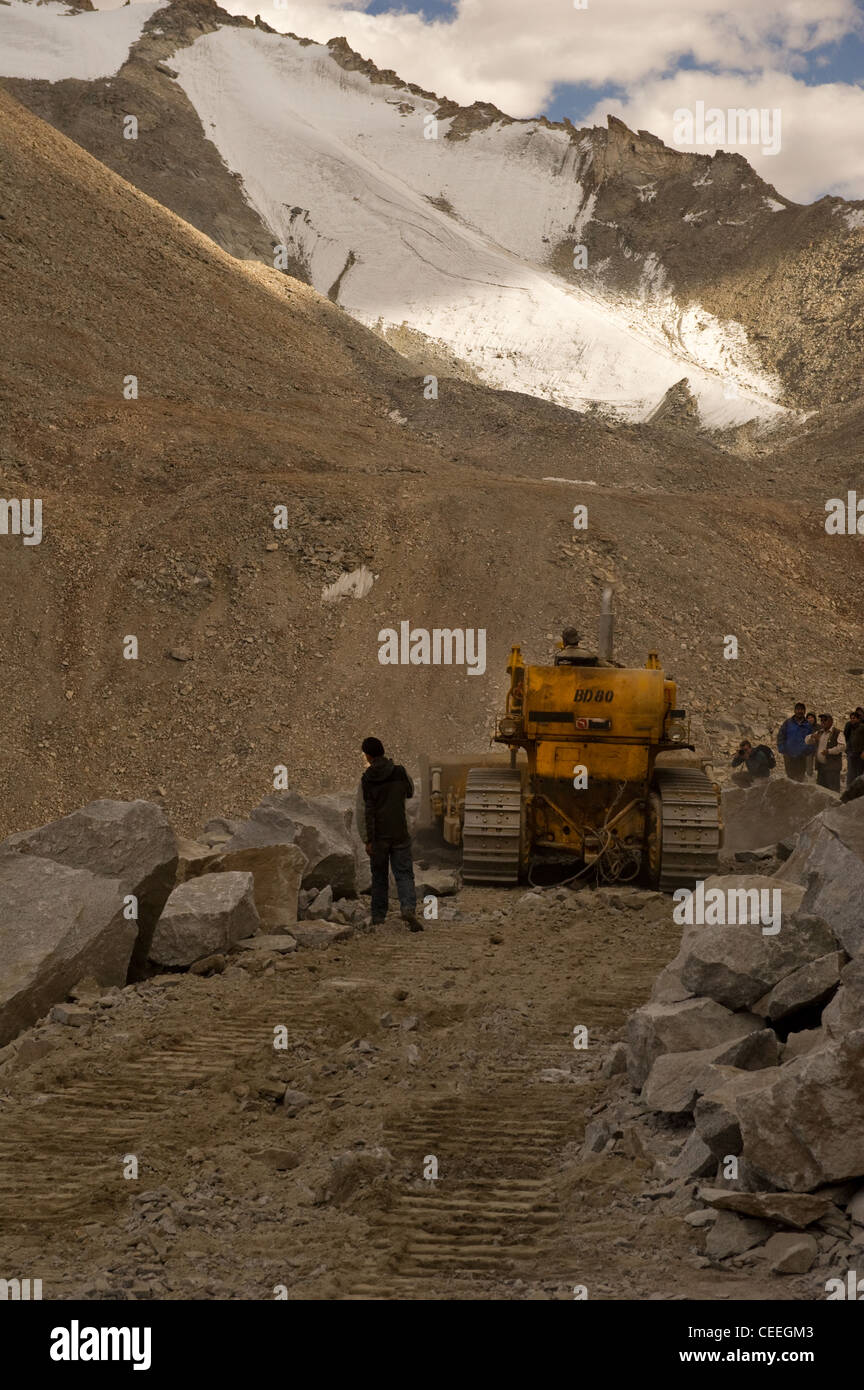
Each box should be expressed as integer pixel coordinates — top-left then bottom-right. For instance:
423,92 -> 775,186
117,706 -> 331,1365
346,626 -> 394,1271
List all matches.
0,801 -> 178,979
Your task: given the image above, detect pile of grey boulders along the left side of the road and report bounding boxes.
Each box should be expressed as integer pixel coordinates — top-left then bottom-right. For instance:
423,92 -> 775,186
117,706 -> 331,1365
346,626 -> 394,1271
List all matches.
0,791 -> 460,1048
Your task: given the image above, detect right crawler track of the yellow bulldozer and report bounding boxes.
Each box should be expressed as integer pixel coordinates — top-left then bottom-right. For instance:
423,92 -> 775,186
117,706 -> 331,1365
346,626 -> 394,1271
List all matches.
654,767 -> 721,892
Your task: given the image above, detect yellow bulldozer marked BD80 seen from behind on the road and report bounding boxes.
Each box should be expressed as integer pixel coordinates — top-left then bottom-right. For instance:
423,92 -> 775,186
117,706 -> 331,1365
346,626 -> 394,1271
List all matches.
418,588 -> 722,892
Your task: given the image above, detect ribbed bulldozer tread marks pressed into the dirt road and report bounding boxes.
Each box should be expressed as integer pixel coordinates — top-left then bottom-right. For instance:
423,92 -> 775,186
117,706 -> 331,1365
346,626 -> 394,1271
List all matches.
0,924 -> 581,1300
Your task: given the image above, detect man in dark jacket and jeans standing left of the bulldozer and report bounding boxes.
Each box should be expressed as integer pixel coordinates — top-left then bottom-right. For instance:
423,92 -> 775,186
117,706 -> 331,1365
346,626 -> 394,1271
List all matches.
354,738 -> 422,931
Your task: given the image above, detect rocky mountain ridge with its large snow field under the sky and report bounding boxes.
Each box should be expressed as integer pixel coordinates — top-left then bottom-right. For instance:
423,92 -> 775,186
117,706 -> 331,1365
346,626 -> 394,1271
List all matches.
0,0 -> 864,428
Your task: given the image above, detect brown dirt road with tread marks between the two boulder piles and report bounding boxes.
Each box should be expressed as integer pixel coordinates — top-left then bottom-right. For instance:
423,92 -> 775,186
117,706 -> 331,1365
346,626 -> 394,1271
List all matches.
0,890 -> 811,1300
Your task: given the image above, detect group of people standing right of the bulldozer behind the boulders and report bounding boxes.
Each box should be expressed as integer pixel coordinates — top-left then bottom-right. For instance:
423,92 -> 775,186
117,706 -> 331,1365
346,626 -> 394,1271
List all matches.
732,701 -> 864,791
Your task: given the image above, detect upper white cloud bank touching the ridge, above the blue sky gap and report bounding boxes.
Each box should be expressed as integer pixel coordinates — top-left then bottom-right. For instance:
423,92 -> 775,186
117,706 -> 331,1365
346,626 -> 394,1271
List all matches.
216,0 -> 861,115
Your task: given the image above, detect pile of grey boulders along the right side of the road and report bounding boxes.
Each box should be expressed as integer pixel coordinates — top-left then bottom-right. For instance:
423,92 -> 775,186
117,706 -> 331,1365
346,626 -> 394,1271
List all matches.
600,788 -> 864,1277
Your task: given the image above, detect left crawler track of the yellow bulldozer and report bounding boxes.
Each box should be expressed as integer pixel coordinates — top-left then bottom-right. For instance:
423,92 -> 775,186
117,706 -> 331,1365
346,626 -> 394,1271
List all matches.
463,767 -> 522,884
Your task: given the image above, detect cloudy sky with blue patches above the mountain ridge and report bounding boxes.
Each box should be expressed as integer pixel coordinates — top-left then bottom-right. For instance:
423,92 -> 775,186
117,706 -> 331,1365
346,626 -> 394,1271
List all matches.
209,0 -> 864,202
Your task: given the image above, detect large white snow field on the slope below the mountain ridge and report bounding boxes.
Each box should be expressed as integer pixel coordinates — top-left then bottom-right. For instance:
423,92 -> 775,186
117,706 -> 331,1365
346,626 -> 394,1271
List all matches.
172,29 -> 781,425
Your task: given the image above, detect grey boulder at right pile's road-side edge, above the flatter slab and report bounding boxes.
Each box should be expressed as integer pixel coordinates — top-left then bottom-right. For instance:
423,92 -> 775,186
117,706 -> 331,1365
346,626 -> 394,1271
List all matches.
626,999 -> 764,1087
